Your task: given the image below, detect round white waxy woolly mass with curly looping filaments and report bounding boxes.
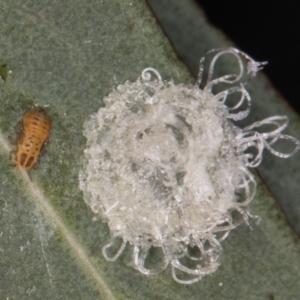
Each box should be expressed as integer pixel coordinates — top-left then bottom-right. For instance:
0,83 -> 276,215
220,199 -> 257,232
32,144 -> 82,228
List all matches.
80,48 -> 299,284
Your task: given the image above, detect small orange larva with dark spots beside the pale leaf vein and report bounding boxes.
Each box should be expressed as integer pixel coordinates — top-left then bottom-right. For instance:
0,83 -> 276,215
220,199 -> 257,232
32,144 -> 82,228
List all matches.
14,108 -> 51,170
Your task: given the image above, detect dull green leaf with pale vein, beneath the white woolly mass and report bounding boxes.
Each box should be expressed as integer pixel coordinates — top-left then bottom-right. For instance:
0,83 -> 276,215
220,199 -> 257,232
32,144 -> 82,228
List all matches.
0,0 -> 300,300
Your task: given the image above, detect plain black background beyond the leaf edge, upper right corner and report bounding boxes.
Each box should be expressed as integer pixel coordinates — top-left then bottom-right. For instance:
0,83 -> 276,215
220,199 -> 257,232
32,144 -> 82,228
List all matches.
195,0 -> 300,114
